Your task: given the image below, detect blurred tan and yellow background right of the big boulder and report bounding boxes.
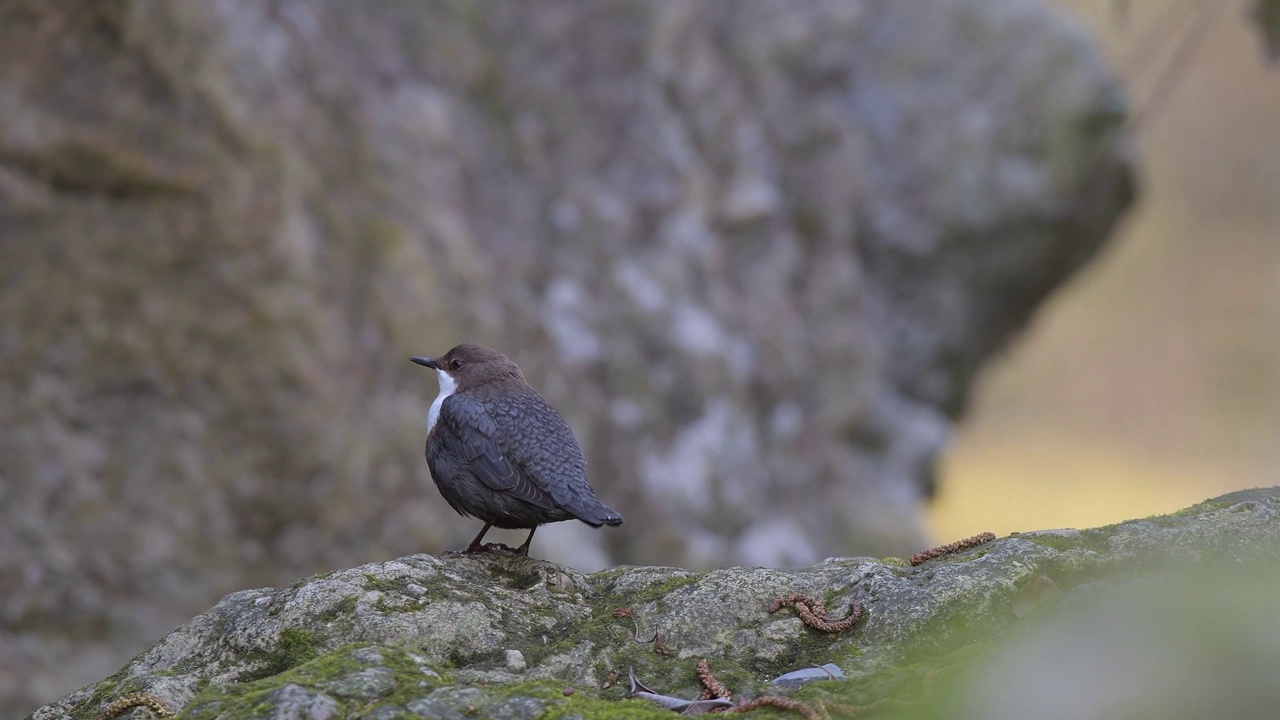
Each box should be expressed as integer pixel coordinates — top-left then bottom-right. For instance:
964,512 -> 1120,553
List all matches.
929,0 -> 1280,541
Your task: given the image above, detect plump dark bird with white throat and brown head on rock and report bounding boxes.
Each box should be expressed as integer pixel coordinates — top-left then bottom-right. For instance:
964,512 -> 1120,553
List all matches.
410,342 -> 622,555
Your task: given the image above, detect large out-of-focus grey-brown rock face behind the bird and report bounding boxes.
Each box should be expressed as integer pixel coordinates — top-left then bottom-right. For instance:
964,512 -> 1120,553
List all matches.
0,0 -> 1130,705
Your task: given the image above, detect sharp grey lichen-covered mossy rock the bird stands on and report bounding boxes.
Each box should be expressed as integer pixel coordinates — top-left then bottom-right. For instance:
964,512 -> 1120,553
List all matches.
36,489 -> 1280,720
